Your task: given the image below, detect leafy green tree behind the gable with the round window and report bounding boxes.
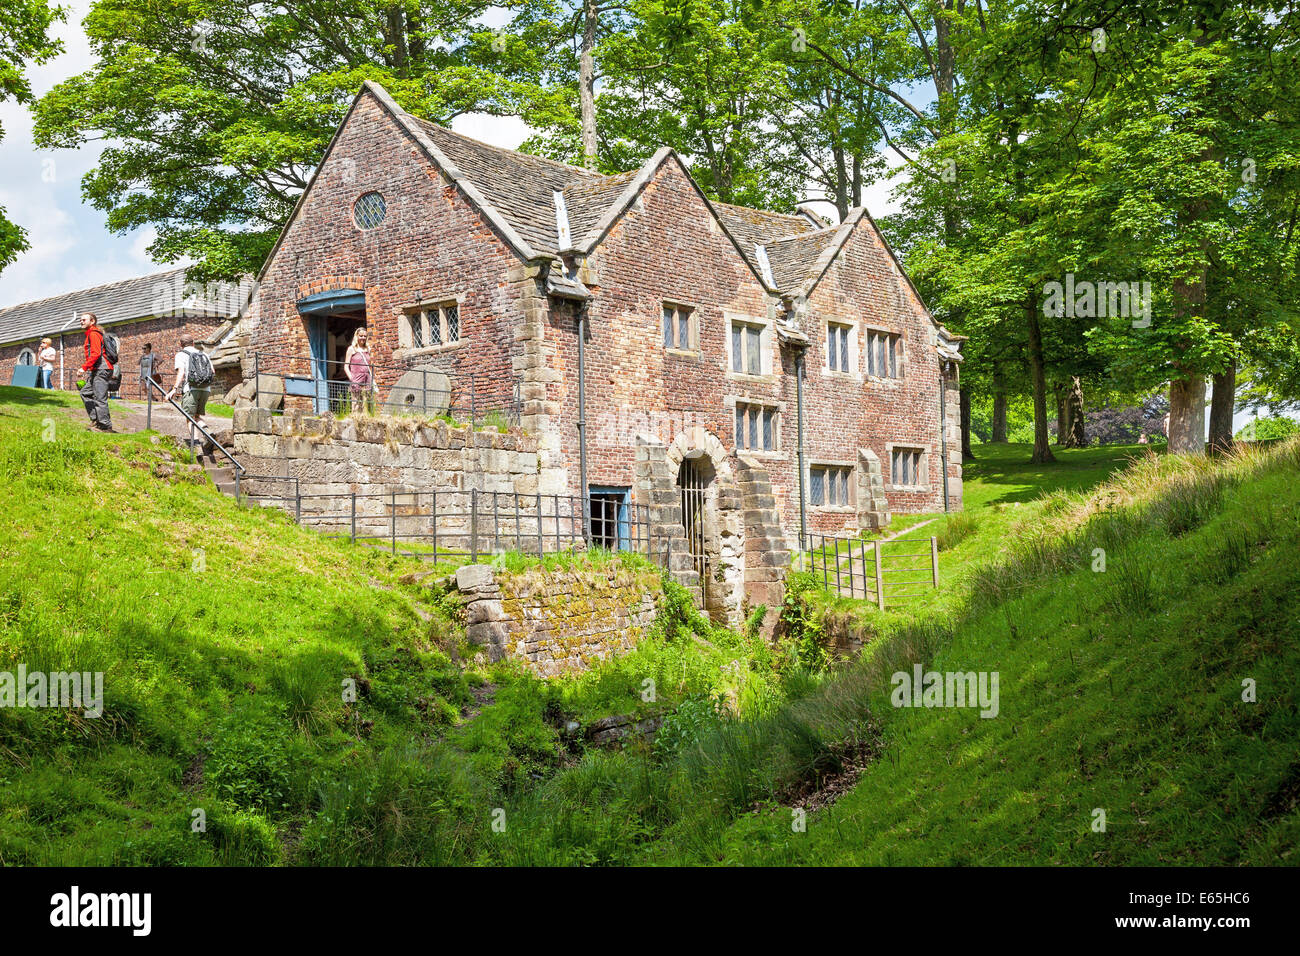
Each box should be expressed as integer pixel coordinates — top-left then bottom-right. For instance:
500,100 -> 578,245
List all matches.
35,0 -> 571,278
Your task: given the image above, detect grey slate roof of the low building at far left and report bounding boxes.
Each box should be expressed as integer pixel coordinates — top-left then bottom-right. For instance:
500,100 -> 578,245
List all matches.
0,268 -> 251,345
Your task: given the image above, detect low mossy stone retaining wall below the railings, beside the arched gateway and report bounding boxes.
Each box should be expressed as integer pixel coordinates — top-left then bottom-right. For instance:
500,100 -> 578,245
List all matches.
455,561 -> 663,678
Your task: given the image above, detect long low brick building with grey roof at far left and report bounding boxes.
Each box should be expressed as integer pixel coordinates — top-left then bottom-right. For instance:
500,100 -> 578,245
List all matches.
0,268 -> 252,398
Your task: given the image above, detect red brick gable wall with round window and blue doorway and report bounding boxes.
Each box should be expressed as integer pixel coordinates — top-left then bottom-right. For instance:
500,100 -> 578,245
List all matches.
244,95 -> 520,403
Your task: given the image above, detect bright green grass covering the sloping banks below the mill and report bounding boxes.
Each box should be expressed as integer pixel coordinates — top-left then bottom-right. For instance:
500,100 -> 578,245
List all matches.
0,389 -> 1300,865
